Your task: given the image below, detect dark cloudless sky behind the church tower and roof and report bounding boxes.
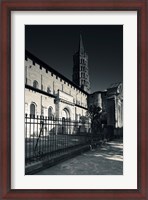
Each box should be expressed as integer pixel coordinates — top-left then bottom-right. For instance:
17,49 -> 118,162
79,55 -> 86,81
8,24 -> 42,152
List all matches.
25,25 -> 123,92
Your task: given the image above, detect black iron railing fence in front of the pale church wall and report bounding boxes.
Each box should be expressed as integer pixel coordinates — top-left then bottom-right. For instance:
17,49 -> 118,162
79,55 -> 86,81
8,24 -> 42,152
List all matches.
25,114 -> 91,165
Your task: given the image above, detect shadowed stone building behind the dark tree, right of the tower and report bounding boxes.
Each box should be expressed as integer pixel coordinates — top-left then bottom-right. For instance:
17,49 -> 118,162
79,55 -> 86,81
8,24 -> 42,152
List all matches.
88,83 -> 123,128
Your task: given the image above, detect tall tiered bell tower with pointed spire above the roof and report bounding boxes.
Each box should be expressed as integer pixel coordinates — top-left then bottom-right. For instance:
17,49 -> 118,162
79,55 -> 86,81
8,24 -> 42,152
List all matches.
72,34 -> 90,93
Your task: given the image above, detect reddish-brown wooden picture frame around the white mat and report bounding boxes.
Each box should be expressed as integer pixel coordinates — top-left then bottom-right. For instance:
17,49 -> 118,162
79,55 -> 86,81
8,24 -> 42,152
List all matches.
0,0 -> 148,200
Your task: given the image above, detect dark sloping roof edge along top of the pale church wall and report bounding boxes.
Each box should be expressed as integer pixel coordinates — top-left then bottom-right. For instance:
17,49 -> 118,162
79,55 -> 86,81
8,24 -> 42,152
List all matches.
25,50 -> 89,95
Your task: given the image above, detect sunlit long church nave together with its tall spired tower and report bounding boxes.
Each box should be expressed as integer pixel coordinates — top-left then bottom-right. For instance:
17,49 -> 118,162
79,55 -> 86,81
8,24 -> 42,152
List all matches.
25,35 -> 90,120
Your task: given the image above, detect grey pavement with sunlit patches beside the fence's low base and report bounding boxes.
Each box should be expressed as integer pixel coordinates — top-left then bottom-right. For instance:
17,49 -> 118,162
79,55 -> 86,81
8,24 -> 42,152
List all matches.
36,140 -> 123,175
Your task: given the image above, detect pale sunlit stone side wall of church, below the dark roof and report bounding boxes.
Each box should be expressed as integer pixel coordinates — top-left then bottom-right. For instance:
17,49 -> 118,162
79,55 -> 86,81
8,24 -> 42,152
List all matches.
25,54 -> 87,120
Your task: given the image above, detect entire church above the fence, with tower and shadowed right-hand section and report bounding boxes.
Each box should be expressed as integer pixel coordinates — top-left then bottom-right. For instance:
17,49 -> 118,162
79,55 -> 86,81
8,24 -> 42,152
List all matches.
25,35 -> 123,134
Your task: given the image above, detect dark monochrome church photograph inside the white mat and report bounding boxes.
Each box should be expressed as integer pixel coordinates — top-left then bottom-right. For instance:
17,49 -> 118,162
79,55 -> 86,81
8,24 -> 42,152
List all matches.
24,25 -> 124,175
